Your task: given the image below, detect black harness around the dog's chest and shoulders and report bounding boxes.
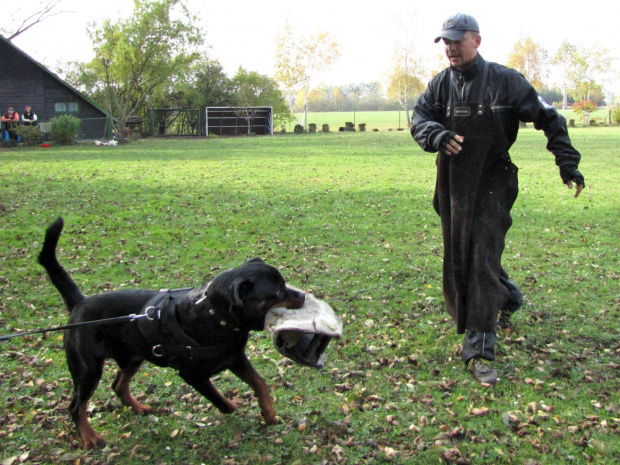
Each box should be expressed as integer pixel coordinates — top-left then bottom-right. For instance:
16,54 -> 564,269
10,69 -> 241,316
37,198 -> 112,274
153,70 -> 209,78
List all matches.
138,284 -> 244,370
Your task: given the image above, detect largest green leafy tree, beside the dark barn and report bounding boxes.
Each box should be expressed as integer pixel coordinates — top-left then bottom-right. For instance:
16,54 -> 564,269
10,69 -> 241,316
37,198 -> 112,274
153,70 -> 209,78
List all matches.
79,0 -> 203,136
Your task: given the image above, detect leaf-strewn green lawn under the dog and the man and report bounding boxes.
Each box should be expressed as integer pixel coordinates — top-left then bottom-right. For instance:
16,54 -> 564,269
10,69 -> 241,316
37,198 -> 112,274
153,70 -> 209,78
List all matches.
0,126 -> 620,465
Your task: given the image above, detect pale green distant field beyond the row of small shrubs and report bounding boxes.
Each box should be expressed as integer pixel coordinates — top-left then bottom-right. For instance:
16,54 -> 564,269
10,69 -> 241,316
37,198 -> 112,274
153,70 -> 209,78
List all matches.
286,109 -> 609,132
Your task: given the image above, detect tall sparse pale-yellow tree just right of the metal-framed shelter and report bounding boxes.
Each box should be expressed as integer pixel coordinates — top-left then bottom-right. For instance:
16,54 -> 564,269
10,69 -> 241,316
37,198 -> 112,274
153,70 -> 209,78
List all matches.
275,23 -> 340,128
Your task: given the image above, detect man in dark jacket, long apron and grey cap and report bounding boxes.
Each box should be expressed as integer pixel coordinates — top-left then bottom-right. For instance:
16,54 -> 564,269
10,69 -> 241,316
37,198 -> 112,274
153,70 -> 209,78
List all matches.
411,13 -> 585,384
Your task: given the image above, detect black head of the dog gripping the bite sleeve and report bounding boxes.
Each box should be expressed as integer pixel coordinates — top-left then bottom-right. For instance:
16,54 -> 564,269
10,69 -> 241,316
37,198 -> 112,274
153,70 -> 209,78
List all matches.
208,258 -> 305,330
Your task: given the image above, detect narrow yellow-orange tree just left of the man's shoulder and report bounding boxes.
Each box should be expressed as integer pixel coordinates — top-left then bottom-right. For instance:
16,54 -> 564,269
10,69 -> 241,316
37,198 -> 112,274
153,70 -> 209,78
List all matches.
387,42 -> 425,126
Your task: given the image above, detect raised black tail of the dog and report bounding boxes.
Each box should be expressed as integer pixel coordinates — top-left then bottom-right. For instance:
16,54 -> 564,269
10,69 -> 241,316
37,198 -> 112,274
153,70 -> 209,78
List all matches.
37,218 -> 85,311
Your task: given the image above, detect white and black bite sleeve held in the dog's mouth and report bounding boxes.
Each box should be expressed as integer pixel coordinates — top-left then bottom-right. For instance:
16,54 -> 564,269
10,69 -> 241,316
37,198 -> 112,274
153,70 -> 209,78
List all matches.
265,294 -> 342,368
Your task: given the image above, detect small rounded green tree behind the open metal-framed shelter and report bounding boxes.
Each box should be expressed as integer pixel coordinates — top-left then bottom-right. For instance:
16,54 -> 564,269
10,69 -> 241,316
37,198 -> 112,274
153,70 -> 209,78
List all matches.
231,67 -> 292,134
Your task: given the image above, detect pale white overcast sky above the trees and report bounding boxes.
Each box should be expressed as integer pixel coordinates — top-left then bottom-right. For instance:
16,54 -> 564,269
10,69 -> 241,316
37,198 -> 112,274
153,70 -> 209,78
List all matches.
6,0 -> 620,95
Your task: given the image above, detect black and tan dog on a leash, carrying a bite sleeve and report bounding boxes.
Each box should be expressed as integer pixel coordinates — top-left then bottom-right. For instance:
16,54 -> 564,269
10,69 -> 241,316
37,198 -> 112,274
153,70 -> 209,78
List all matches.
38,218 -> 305,449
